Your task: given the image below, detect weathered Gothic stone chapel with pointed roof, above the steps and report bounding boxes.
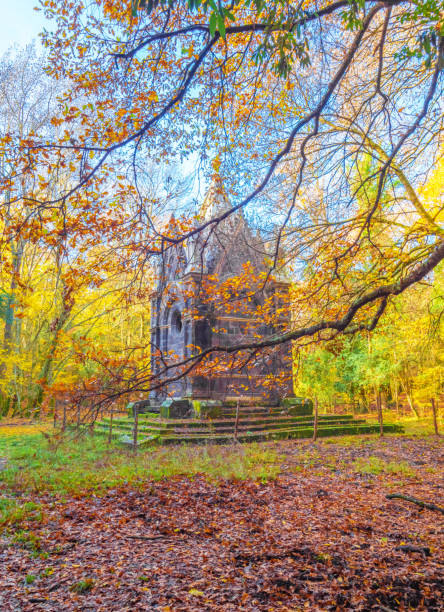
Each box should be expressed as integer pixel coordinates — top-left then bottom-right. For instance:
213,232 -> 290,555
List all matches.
151,178 -> 293,400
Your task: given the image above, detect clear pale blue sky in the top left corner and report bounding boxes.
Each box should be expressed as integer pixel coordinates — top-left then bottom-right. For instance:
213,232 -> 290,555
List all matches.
0,0 -> 47,55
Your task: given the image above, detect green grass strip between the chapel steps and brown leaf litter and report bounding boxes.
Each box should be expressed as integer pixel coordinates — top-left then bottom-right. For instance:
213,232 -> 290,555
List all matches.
0,433 -> 282,500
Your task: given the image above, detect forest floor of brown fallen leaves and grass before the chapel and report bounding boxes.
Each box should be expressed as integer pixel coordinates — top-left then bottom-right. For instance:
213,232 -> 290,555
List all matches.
0,424 -> 444,612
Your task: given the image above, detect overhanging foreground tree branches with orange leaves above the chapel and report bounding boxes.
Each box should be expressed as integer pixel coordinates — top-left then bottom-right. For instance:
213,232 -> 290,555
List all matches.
0,0 -> 444,402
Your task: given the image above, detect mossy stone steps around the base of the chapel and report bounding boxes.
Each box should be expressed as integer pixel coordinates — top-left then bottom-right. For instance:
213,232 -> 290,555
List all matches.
95,405 -> 402,446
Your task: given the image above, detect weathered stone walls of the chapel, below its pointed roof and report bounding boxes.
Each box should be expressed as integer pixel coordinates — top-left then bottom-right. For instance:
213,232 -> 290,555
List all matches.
152,278 -> 293,399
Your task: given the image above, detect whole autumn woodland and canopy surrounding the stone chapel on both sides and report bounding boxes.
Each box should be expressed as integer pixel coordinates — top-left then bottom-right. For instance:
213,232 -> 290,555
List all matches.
0,1 -> 444,417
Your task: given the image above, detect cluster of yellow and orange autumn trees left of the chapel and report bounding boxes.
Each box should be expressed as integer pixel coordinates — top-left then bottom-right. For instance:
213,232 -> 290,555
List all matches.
0,46 -> 183,416
